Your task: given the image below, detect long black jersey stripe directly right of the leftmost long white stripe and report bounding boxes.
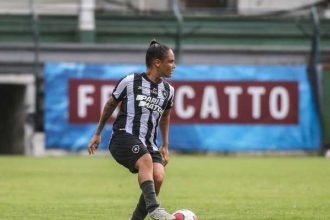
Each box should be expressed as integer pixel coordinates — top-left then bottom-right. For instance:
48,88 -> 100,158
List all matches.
132,74 -> 142,137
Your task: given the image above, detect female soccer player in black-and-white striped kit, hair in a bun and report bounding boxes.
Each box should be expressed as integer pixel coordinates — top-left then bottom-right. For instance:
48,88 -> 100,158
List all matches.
88,40 -> 175,220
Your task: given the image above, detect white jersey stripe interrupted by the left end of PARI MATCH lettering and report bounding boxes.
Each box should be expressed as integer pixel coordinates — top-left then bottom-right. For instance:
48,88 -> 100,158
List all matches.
139,77 -> 150,145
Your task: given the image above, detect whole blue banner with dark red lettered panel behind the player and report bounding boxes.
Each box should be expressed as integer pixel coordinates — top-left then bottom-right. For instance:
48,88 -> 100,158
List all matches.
44,63 -> 320,151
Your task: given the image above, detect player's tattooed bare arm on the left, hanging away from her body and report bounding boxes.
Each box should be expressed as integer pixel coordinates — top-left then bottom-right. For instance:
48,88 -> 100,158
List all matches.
88,96 -> 118,154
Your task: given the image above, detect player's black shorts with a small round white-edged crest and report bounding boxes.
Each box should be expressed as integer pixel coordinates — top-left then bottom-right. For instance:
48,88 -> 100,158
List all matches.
109,131 -> 164,173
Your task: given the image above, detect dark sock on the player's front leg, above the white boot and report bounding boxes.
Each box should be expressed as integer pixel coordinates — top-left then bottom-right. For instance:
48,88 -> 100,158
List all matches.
140,180 -> 159,213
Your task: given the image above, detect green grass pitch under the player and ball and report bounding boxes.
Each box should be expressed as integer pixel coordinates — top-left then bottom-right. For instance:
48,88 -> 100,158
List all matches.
0,155 -> 330,220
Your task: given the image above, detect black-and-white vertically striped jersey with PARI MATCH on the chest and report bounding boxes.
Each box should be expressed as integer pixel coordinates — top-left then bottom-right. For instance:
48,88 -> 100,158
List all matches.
112,73 -> 174,151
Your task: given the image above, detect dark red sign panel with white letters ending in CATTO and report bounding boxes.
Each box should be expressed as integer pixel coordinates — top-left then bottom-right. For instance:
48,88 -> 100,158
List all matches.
68,79 -> 299,124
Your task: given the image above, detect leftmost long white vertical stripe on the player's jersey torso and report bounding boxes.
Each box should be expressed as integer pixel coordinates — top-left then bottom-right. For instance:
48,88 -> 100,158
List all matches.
125,74 -> 135,134
